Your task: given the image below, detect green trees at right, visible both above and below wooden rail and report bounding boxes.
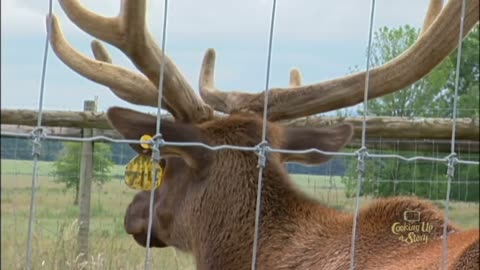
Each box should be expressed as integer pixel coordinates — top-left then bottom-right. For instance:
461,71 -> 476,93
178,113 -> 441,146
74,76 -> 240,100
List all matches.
343,25 -> 480,201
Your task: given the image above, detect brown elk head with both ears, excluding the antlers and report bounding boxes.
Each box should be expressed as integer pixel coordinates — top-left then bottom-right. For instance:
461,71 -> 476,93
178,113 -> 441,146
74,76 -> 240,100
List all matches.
108,108 -> 352,250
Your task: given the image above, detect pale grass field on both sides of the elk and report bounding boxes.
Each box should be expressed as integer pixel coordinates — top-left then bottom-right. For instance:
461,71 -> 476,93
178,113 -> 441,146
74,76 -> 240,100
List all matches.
1,160 -> 479,269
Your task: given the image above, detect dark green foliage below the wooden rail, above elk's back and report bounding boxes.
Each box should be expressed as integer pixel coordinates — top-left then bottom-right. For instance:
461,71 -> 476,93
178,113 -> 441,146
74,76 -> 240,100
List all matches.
342,151 -> 480,202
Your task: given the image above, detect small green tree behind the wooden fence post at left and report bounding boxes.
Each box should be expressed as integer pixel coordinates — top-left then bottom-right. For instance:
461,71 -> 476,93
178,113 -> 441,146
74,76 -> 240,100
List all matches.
53,142 -> 113,205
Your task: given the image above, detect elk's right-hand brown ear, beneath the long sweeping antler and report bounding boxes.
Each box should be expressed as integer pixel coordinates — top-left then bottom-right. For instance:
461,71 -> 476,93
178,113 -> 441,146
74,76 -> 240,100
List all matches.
281,124 -> 353,164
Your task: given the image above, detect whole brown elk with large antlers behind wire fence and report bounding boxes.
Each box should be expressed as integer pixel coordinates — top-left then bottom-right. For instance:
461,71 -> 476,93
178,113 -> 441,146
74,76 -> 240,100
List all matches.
47,0 -> 479,269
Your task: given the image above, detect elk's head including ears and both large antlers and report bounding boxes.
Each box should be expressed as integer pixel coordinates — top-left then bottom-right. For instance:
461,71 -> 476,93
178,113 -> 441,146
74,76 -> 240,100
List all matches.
47,0 -> 479,266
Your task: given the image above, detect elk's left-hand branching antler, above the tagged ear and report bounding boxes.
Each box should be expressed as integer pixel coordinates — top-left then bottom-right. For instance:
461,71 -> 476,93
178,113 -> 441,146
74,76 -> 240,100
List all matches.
49,0 -> 213,122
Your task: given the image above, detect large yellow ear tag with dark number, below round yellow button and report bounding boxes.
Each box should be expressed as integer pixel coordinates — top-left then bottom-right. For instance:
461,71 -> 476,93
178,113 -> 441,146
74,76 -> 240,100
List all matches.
125,155 -> 163,190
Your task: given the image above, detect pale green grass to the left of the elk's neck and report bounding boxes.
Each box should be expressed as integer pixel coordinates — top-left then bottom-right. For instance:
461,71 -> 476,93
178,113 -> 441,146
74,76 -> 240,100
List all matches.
1,175 -> 193,269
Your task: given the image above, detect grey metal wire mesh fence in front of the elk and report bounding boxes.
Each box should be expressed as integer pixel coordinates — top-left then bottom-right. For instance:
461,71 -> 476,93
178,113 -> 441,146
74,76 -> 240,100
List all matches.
2,0 -> 479,269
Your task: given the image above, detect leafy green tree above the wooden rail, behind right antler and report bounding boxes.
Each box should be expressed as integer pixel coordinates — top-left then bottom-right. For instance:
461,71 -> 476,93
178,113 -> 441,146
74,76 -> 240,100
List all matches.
360,25 -> 480,117
